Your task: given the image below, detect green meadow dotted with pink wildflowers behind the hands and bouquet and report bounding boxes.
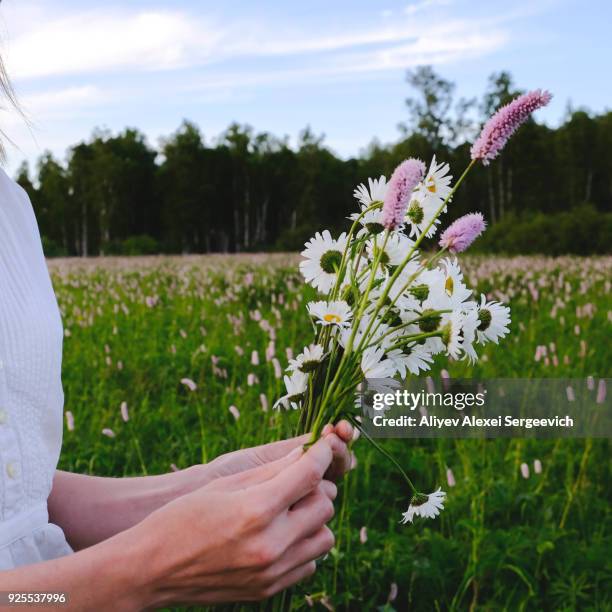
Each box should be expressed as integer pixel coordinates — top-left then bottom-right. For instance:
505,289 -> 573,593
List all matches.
50,254 -> 612,610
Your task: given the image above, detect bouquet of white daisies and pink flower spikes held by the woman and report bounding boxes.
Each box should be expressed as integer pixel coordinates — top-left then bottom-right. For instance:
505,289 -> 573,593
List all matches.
276,90 -> 551,523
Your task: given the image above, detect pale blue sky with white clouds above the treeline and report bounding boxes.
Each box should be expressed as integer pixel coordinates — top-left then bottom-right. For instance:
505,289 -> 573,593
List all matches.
0,0 -> 612,172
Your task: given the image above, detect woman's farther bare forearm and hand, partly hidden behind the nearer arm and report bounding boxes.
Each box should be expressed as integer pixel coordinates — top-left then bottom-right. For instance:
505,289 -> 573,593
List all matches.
48,421 -> 353,550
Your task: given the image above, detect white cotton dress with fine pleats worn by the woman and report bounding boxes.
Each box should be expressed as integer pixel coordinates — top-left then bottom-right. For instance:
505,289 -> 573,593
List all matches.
0,169 -> 73,571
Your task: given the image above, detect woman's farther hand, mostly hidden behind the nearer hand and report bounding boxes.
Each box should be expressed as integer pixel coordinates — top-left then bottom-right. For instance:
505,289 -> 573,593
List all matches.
201,421 -> 353,484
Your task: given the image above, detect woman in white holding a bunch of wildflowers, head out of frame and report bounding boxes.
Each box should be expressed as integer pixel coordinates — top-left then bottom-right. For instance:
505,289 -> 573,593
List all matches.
0,52 -> 352,610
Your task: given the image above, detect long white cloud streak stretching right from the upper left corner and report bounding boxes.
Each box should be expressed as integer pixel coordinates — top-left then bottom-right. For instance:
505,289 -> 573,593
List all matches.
0,0 -> 505,80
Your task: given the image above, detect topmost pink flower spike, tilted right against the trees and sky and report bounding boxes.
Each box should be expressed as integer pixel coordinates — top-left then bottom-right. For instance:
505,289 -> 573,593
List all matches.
471,89 -> 552,166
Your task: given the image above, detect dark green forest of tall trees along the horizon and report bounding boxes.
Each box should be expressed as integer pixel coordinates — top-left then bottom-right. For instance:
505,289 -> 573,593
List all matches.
16,66 -> 612,257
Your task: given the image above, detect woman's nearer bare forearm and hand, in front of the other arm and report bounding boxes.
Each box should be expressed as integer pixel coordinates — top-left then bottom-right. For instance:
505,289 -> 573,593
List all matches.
0,439 -> 336,611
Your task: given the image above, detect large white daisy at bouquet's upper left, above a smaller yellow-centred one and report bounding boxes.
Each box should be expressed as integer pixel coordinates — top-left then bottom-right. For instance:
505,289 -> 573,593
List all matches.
300,230 -> 347,293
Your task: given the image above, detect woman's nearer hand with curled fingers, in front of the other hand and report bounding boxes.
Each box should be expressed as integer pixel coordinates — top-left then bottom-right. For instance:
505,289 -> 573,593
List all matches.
130,434 -> 338,606
